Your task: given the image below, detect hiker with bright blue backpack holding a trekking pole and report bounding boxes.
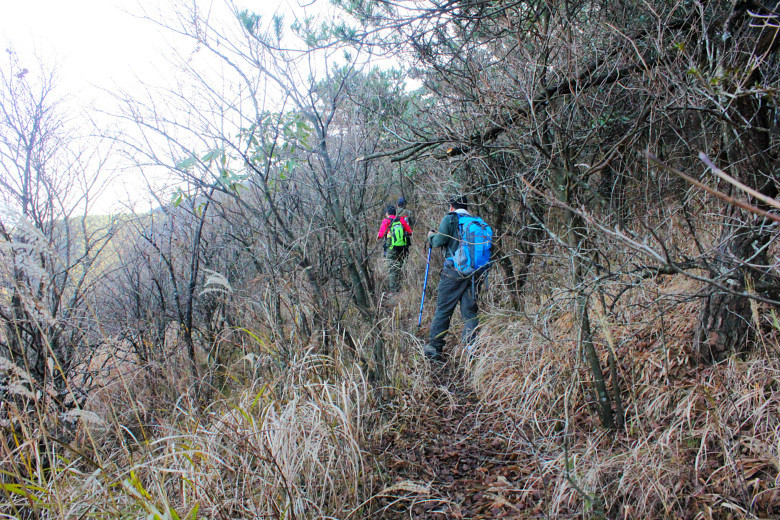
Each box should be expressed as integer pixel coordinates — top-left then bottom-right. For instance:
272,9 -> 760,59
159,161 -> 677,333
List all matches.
424,195 -> 493,361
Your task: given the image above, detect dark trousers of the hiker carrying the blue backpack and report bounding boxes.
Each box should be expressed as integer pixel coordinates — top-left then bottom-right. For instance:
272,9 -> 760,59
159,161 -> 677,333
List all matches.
426,266 -> 481,356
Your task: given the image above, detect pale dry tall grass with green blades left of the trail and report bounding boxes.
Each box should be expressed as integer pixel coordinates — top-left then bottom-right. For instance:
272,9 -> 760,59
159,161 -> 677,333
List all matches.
0,342 -> 384,519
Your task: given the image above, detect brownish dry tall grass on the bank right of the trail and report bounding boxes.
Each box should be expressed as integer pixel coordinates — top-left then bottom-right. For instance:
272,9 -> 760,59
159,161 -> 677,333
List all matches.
464,279 -> 780,519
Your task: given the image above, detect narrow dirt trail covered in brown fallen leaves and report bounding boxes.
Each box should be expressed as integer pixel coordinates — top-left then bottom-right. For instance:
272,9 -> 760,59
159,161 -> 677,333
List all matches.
374,361 -> 540,519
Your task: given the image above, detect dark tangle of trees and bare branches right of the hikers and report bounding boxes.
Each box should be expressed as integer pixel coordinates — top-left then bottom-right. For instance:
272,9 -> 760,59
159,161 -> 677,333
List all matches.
343,1 -> 780,425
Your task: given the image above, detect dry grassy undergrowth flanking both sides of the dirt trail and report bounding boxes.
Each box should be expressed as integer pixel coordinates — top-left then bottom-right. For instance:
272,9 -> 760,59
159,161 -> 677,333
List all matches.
0,266 -> 780,520
